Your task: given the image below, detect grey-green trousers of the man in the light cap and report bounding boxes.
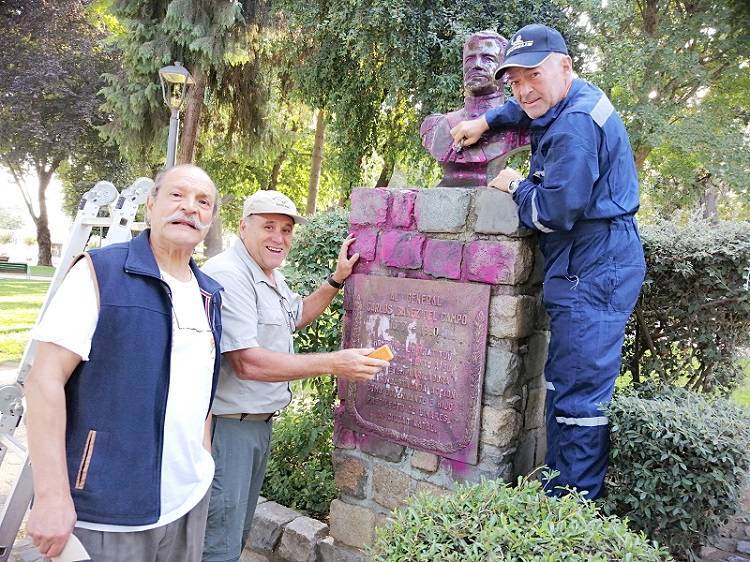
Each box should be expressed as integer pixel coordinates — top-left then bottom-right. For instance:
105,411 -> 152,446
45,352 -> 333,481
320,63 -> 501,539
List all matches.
203,416 -> 272,562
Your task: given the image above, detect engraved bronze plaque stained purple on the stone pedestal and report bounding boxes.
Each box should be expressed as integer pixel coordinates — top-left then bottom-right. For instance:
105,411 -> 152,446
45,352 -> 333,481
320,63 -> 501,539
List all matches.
342,275 -> 490,464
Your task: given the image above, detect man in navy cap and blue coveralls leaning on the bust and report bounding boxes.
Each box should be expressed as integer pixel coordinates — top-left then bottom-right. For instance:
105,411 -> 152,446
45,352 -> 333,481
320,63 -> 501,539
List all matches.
451,24 -> 645,499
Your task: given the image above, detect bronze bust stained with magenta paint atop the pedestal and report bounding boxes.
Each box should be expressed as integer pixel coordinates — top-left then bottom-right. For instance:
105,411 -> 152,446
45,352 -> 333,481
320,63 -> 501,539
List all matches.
419,31 -> 529,187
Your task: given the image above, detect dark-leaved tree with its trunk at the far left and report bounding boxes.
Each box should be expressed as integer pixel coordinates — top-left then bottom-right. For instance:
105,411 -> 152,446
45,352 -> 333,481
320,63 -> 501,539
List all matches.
0,0 -> 117,265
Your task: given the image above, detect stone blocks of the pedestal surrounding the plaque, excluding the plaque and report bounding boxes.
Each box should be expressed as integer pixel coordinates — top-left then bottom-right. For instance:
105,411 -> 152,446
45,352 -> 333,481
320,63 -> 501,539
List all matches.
329,188 -> 548,560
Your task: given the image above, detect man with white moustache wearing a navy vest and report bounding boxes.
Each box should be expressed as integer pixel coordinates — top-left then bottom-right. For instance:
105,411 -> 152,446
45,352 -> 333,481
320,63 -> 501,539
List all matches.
26,165 -> 221,562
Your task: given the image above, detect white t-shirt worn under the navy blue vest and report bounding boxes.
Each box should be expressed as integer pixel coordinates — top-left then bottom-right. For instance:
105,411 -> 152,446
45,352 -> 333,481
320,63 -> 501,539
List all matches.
31,259 -> 216,532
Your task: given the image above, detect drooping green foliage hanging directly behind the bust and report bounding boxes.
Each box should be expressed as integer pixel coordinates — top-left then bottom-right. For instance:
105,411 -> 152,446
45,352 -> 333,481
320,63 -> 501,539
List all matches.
282,0 -> 579,187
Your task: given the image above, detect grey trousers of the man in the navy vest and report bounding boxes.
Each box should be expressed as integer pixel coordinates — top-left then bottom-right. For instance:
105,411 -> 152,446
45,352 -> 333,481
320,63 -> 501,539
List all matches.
73,488 -> 208,562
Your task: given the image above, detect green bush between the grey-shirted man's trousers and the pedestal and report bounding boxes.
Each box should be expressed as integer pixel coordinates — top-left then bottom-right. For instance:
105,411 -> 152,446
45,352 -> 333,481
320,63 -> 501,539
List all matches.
261,394 -> 336,516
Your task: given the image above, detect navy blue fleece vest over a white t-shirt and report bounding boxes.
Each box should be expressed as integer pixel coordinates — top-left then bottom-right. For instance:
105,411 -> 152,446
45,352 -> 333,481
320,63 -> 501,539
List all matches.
65,230 -> 221,525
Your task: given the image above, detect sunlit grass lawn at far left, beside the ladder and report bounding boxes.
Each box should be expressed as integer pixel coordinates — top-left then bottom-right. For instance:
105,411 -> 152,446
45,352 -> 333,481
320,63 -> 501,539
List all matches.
0,276 -> 51,363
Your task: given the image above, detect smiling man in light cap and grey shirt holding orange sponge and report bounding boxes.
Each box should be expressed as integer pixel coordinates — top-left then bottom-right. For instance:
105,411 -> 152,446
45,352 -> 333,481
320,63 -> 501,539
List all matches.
203,191 -> 388,562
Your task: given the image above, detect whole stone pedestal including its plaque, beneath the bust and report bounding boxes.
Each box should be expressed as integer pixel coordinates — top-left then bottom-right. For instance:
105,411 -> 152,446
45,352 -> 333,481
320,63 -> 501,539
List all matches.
321,187 -> 547,562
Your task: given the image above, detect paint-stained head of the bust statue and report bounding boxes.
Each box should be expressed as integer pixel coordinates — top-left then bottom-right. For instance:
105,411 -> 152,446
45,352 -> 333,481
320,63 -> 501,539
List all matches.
463,30 -> 508,96
